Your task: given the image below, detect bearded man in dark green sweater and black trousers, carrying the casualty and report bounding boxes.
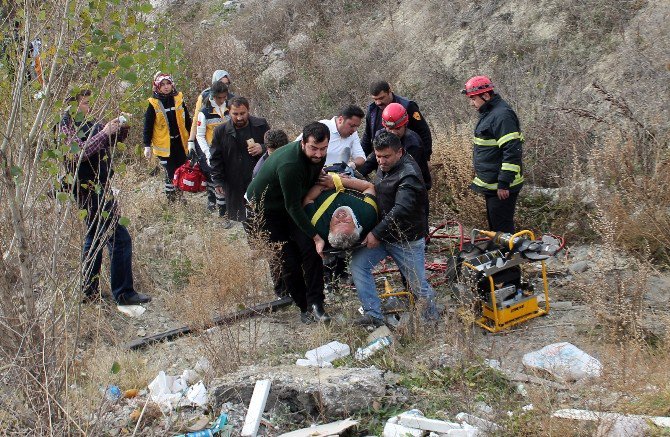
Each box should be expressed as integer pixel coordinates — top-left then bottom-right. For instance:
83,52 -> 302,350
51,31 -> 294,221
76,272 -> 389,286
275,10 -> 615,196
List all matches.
246,122 -> 330,323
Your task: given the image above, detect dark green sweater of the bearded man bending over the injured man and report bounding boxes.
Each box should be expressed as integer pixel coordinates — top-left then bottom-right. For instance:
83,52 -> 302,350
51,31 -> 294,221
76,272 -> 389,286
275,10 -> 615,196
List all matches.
247,141 -> 325,238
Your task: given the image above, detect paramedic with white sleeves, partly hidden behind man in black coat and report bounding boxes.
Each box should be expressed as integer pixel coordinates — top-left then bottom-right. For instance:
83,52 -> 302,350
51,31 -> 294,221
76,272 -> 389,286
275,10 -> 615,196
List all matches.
197,82 -> 230,217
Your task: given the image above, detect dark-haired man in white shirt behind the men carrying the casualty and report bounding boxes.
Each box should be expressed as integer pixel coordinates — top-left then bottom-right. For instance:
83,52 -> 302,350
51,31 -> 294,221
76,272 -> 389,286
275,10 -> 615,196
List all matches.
296,105 -> 365,168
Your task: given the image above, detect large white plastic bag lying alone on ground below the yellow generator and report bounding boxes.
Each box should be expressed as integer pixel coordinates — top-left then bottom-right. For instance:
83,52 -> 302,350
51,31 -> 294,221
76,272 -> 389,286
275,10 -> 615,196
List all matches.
522,342 -> 603,382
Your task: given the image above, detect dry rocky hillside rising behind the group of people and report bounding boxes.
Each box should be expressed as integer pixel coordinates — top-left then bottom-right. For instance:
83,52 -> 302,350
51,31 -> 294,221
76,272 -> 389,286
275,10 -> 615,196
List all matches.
169,0 -> 670,186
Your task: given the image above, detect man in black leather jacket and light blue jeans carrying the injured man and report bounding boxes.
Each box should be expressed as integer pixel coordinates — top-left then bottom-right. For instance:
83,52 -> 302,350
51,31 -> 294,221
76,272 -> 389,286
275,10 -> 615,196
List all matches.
351,132 -> 439,326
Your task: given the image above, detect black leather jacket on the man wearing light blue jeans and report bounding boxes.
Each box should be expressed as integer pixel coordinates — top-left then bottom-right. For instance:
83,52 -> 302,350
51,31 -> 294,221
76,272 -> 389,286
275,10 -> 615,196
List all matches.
372,153 -> 428,243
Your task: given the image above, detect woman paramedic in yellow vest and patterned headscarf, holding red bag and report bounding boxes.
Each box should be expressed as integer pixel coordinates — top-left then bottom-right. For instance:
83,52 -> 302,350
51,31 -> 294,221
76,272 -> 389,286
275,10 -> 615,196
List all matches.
144,71 -> 191,202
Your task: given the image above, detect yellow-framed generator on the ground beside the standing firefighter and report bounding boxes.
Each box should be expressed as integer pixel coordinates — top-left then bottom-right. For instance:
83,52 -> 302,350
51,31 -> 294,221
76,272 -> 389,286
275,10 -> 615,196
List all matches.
457,229 -> 563,333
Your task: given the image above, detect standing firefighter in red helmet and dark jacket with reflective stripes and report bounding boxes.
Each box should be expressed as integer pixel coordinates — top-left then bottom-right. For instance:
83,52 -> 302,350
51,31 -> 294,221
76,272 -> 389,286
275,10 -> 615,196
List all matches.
468,76 -> 524,233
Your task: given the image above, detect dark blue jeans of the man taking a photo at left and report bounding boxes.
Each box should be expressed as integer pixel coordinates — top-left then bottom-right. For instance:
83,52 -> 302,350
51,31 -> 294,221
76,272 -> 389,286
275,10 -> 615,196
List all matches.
83,202 -> 135,301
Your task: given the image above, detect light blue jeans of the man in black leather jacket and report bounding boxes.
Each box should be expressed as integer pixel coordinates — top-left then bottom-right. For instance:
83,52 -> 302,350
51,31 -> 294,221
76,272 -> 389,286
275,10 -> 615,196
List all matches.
351,238 -> 436,319
